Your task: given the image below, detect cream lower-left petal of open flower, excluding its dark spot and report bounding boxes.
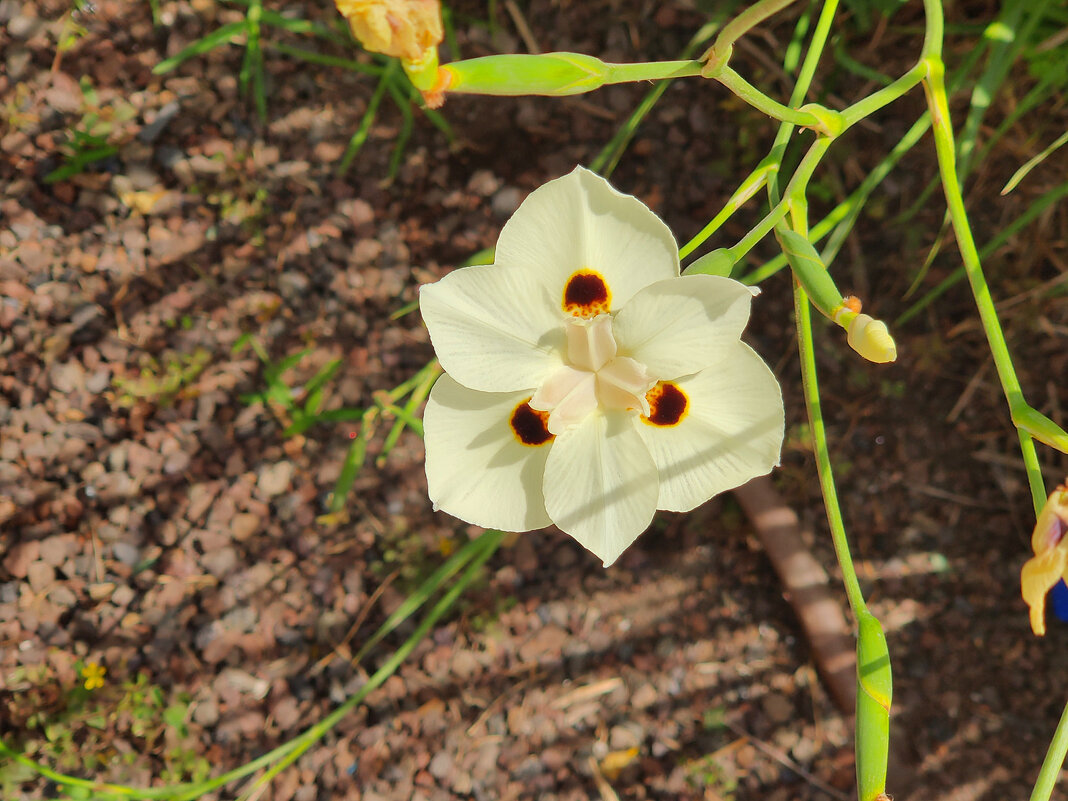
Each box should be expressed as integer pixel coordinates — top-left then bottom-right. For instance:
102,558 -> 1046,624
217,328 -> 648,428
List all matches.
423,375 -> 552,531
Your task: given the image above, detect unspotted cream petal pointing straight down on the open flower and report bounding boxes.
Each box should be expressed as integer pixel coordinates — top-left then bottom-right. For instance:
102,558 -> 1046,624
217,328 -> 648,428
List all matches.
545,412 -> 658,567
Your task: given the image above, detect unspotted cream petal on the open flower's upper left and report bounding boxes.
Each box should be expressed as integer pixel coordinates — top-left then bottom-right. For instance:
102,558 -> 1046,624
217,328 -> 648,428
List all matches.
419,264 -> 566,392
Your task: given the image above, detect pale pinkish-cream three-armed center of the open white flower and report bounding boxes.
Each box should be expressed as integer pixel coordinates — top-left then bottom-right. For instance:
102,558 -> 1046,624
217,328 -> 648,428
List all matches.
530,314 -> 656,435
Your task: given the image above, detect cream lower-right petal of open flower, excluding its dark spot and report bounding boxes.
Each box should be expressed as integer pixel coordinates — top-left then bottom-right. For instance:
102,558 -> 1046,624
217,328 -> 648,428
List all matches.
632,342 -> 784,514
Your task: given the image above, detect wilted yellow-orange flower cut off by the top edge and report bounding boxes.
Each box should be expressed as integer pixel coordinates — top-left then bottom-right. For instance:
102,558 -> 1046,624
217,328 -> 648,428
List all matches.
336,0 -> 444,62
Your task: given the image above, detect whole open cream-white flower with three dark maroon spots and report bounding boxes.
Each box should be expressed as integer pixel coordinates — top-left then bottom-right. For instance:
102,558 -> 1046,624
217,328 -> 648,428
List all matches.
420,168 -> 783,566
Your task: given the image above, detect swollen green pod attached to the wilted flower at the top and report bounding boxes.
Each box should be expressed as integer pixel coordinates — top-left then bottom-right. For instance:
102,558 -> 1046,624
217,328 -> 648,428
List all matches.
441,52 -> 609,97
